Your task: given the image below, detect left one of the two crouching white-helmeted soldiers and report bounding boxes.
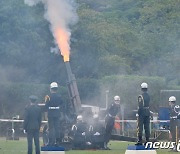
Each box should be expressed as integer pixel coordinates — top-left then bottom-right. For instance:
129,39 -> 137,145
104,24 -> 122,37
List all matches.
72,115 -> 87,149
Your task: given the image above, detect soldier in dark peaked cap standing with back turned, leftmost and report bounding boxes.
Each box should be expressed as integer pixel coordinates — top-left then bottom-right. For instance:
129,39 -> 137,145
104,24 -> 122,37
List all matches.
23,95 -> 41,154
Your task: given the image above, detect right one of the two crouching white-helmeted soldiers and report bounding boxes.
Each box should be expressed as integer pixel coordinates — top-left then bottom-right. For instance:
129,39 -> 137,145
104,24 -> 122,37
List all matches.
89,114 -> 105,149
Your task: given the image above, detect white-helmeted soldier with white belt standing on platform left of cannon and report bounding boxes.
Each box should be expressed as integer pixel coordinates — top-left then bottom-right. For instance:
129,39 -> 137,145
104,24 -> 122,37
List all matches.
45,82 -> 63,146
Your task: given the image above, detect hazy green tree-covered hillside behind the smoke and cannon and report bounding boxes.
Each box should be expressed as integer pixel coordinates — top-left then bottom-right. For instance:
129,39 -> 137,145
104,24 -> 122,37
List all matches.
0,0 -> 180,115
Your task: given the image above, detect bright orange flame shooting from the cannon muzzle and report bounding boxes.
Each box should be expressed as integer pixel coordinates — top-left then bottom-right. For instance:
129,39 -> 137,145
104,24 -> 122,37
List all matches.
55,28 -> 70,62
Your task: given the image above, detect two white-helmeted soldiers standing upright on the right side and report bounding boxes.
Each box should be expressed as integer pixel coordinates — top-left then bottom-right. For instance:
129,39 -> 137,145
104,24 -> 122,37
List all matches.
136,82 -> 180,151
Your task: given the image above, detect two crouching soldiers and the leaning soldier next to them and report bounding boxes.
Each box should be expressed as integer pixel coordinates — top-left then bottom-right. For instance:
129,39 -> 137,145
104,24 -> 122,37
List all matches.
72,96 -> 120,150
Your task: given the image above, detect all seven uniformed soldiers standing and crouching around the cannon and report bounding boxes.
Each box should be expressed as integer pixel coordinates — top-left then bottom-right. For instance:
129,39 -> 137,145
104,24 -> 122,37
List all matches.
24,82 -> 180,154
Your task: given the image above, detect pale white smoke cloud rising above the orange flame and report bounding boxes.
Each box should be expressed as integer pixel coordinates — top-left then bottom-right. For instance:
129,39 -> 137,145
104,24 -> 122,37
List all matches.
24,0 -> 78,47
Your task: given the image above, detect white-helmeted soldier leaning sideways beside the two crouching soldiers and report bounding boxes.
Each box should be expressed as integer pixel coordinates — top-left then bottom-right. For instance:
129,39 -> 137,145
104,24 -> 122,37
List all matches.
104,96 -> 120,150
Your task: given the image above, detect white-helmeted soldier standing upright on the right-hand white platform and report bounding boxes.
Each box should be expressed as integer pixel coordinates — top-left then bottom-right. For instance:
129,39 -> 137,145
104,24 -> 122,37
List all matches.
136,83 -> 150,145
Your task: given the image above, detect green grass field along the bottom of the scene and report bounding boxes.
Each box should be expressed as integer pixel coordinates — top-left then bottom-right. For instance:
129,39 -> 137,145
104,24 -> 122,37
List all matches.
0,138 -> 175,154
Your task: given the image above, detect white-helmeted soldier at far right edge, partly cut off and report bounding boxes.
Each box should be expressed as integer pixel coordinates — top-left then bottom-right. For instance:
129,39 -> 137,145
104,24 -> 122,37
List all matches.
169,96 -> 180,151
